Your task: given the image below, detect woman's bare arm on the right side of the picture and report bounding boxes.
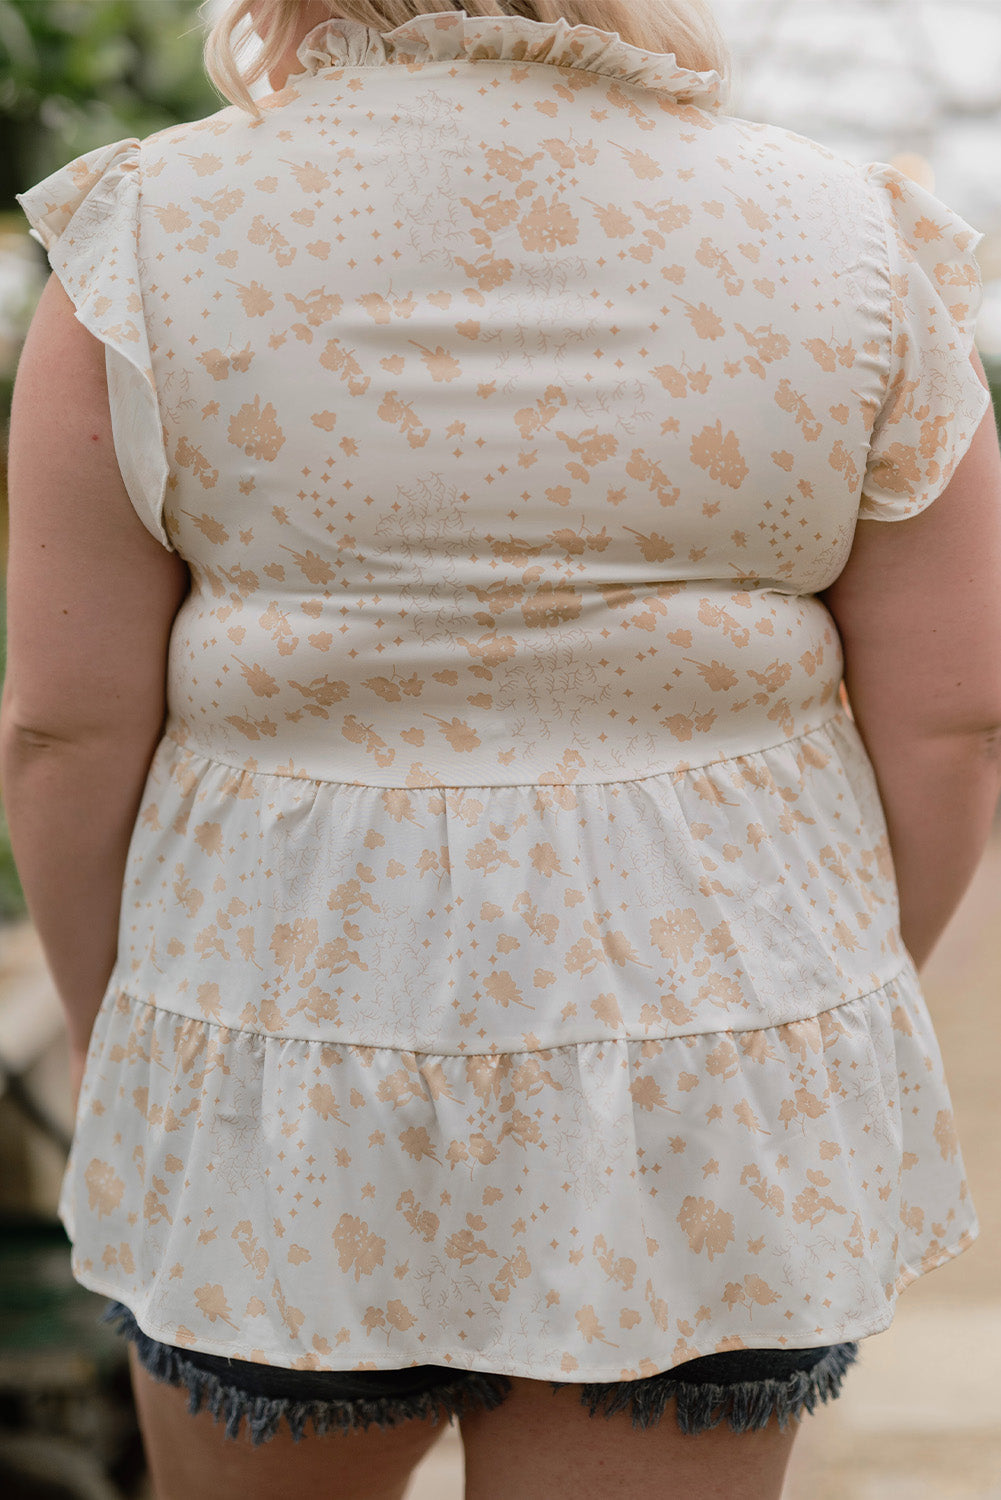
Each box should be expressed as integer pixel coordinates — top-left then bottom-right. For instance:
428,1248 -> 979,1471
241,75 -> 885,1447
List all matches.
819,356 -> 1001,968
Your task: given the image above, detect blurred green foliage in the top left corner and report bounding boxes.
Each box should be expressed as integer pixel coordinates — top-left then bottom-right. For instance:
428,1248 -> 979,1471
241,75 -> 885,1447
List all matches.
0,0 -> 219,212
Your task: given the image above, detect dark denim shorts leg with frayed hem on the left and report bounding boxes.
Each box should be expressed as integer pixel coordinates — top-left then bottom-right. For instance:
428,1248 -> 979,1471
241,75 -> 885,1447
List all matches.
101,1304 -> 510,1448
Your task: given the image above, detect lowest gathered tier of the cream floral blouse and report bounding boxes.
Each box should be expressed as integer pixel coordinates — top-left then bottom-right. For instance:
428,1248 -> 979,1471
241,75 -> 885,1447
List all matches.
60,969 -> 978,1383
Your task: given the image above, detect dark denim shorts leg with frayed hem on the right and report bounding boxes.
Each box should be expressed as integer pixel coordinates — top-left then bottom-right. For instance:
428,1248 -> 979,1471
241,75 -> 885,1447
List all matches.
549,1344 -> 858,1436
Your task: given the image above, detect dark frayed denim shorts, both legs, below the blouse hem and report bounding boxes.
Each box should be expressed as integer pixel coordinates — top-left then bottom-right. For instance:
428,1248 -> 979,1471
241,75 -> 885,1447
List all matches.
101,1302 -> 858,1446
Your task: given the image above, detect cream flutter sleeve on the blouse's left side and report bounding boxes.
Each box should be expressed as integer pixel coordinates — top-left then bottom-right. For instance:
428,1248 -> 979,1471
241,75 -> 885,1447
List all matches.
18,140 -> 174,552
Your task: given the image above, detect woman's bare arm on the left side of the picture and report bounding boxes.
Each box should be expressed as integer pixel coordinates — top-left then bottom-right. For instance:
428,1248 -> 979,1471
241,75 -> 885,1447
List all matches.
0,276 -> 189,1079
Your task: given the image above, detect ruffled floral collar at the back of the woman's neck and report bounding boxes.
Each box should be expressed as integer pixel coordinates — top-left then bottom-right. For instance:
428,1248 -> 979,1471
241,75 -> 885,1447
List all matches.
299,11 -> 723,110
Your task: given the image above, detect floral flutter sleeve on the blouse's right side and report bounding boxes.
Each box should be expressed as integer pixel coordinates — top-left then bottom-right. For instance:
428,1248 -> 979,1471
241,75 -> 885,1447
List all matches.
858,162 -> 990,521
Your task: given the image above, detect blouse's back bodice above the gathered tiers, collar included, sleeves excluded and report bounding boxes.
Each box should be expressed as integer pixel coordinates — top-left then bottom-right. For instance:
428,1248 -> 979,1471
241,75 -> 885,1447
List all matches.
99,15 -> 978,785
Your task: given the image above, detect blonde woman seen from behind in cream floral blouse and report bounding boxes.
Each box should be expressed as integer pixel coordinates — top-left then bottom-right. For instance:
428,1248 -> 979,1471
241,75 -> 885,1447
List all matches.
3,0 -> 1001,1500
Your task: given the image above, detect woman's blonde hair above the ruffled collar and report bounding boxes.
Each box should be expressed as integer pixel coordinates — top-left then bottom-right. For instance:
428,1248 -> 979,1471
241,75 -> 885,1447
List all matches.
206,0 -> 729,114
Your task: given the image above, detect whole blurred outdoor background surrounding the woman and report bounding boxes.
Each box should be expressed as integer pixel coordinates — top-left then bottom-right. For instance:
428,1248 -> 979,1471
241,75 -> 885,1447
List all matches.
0,0 -> 1001,1500
